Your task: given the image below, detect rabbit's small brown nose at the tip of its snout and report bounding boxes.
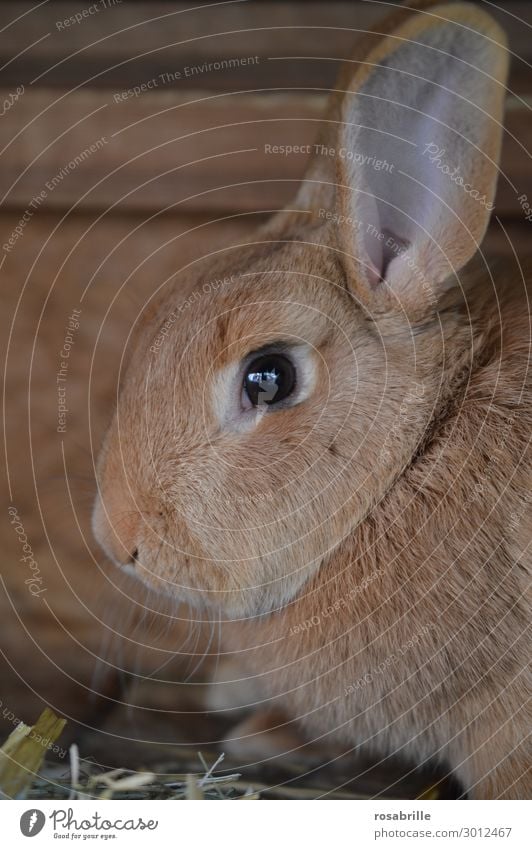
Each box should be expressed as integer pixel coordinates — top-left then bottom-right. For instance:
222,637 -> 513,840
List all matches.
92,496 -> 141,566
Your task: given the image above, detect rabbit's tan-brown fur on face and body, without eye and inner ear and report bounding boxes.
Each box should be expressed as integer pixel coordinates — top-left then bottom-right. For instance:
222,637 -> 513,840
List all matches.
94,4 -> 532,798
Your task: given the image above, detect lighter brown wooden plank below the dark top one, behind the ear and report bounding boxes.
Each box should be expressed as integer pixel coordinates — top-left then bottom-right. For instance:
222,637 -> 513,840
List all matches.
0,89 -> 532,219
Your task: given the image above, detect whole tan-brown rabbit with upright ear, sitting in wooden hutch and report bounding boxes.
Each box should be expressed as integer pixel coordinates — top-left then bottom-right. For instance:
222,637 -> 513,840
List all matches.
94,2 -> 532,798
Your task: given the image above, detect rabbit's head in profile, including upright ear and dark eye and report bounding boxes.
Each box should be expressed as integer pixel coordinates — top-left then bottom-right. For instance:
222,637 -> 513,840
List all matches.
94,3 -> 507,617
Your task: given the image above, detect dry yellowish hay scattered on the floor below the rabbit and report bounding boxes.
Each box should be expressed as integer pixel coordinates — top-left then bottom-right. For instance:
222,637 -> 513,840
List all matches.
0,711 -> 452,801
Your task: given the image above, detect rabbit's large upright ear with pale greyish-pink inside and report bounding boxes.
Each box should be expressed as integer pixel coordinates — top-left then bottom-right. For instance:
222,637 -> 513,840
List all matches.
318,3 -> 508,311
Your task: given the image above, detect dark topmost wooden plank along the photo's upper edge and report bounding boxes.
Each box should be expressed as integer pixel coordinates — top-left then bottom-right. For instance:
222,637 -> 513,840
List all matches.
0,0 -> 532,91
